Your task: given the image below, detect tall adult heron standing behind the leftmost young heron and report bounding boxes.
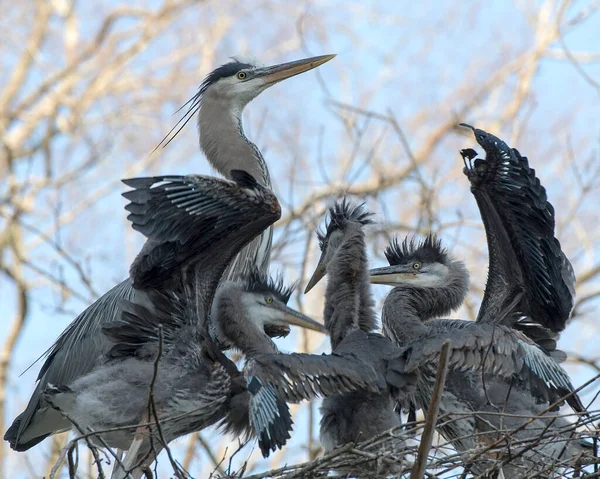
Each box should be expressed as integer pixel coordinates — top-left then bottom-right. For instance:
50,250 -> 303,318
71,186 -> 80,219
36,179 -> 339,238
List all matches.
4,55 -> 334,451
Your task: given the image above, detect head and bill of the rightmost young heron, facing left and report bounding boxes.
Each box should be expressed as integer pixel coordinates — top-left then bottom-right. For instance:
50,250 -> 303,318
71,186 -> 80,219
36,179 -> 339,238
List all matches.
369,234 -> 451,288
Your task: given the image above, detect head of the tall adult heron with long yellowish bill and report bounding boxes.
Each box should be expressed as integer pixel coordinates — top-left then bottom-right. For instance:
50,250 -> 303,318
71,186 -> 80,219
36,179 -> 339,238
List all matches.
198,55 -> 335,113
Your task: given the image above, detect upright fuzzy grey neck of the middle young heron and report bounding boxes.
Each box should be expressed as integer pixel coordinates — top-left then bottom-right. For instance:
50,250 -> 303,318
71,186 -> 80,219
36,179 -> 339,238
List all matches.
324,223 -> 376,348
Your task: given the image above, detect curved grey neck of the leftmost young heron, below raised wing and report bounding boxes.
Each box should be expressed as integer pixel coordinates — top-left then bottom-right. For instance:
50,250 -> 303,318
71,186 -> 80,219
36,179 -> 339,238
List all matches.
211,283 -> 279,357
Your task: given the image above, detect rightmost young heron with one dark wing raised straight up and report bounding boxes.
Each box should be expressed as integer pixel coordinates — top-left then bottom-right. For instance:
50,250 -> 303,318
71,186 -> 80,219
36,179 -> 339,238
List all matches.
371,124 -> 588,477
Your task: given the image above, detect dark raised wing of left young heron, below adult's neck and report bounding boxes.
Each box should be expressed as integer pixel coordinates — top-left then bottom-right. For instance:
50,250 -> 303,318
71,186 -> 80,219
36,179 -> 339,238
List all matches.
123,170 -> 281,336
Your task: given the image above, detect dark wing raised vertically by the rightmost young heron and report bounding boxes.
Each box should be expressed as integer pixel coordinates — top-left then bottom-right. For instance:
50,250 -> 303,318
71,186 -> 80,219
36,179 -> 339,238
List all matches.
461,125 -> 575,342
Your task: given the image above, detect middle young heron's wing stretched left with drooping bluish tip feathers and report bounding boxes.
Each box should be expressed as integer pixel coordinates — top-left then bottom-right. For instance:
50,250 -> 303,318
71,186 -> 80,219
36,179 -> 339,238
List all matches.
246,330 -> 419,454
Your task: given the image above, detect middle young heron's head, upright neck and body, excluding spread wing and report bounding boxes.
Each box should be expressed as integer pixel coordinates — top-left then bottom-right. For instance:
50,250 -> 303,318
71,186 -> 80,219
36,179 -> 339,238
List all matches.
306,200 -> 417,462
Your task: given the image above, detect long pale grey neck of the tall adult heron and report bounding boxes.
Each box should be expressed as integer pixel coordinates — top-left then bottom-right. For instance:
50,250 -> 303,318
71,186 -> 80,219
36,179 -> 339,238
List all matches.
198,92 -> 271,188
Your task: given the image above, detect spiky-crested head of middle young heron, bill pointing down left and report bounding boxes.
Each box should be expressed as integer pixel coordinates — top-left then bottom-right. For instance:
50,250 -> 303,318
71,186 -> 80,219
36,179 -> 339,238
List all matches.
304,198 -> 373,293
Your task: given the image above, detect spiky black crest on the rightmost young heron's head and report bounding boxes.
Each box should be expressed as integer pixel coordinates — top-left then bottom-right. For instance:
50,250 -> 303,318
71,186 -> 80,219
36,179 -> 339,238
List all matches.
384,233 -> 448,266
